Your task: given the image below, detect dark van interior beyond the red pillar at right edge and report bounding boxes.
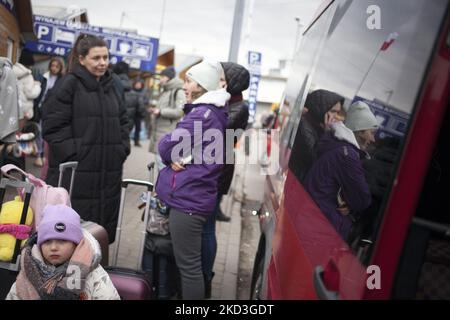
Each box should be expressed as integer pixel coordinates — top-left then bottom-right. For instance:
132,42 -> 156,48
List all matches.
393,107 -> 450,300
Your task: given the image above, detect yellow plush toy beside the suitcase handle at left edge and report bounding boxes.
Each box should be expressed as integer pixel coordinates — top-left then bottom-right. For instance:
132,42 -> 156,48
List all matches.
0,196 -> 33,262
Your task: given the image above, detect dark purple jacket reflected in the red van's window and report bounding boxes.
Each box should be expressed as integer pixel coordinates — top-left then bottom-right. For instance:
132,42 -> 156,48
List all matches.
304,125 -> 371,239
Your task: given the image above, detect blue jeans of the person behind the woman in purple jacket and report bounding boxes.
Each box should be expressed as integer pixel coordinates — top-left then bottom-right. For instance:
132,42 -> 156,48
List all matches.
202,195 -> 222,281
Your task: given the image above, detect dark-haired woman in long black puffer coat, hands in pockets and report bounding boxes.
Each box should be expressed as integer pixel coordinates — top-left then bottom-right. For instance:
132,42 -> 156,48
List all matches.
42,34 -> 130,243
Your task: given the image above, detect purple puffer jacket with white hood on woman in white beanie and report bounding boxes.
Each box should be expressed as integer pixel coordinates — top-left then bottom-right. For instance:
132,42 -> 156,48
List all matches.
156,90 -> 230,215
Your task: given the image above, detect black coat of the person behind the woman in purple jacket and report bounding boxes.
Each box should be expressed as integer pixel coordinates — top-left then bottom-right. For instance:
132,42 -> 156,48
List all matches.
218,97 -> 248,195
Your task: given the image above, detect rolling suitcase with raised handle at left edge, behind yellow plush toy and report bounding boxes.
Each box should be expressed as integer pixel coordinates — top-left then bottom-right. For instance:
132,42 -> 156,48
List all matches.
0,178 -> 34,300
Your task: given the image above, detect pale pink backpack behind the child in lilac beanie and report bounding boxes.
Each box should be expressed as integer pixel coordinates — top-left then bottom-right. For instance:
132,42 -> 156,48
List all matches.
1,164 -> 71,230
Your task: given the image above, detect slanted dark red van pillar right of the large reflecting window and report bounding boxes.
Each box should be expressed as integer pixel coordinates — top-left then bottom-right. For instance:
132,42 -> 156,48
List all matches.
365,15 -> 450,299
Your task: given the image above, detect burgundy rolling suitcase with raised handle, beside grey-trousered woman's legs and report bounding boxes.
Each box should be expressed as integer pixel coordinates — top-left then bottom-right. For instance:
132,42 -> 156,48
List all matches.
105,179 -> 153,300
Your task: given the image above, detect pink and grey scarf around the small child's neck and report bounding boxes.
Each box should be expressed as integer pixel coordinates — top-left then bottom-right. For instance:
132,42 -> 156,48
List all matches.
16,230 -> 101,300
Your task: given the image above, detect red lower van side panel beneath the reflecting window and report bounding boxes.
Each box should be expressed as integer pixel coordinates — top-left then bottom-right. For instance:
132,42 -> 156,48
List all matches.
269,172 -> 366,299
